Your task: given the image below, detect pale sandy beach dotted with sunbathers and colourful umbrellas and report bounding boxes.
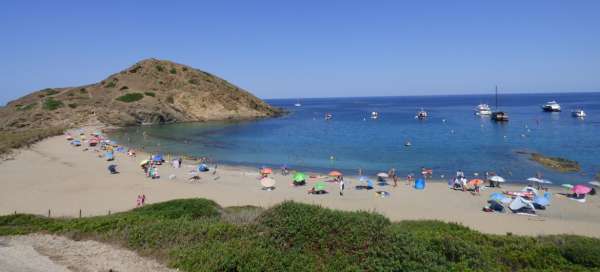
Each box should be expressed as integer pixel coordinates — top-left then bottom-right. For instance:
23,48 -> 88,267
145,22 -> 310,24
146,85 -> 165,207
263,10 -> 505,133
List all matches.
0,128 -> 600,237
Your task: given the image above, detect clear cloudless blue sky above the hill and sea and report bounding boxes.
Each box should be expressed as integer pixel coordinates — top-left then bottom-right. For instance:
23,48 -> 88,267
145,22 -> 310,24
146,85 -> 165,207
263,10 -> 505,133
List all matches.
0,0 -> 600,104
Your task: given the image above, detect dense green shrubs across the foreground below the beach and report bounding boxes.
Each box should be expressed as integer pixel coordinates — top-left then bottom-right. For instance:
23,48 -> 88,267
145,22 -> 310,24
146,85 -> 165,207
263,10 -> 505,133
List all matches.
0,199 -> 600,271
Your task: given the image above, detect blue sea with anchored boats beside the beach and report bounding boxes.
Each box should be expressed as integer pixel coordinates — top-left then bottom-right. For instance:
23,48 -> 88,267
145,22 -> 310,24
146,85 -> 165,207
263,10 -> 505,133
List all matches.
111,93 -> 600,183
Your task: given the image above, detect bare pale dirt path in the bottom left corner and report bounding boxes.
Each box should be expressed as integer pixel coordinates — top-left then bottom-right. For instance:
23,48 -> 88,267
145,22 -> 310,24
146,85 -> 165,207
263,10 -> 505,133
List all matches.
0,234 -> 176,272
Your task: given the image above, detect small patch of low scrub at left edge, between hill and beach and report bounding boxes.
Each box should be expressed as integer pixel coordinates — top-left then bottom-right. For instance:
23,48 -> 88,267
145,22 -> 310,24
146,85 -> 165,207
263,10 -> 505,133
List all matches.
0,127 -> 64,154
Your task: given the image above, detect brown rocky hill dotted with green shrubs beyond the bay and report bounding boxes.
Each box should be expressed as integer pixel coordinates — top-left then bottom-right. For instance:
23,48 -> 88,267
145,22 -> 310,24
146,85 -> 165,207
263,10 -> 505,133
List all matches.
0,59 -> 281,130
